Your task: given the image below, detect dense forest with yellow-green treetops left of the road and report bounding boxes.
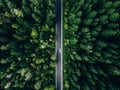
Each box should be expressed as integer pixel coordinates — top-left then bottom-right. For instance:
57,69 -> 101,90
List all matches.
0,0 -> 55,90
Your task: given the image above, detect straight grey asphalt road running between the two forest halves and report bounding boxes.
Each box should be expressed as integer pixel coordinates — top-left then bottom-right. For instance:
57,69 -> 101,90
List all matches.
56,0 -> 63,90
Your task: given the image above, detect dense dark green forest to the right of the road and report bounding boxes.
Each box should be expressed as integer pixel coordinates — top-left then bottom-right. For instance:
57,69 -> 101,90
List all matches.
64,0 -> 120,90
